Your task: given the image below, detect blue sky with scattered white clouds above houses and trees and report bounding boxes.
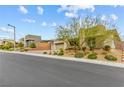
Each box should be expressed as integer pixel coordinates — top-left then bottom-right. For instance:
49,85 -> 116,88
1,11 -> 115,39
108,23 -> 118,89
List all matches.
0,5 -> 124,40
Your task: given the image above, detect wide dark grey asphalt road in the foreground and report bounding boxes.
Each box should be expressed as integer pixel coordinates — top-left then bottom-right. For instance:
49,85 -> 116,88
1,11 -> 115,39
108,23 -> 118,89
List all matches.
0,53 -> 124,87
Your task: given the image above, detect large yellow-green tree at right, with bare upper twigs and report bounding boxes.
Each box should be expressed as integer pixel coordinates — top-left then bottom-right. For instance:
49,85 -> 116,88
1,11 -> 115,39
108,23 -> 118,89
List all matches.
79,16 -> 120,50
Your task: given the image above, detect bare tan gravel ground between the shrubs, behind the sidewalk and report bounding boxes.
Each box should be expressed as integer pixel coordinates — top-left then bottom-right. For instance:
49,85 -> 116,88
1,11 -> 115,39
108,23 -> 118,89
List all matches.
27,49 -> 122,62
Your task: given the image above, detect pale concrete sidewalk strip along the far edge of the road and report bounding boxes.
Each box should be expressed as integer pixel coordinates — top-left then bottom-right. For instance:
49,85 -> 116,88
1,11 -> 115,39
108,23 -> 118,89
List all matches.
0,50 -> 124,68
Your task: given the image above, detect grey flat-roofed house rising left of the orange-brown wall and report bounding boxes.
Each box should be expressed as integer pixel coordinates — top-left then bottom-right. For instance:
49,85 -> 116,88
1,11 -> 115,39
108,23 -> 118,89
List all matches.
24,35 -> 41,47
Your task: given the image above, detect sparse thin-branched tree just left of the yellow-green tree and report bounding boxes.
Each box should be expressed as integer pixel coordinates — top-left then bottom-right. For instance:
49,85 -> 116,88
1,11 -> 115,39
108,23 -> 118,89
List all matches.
57,18 -> 80,49
